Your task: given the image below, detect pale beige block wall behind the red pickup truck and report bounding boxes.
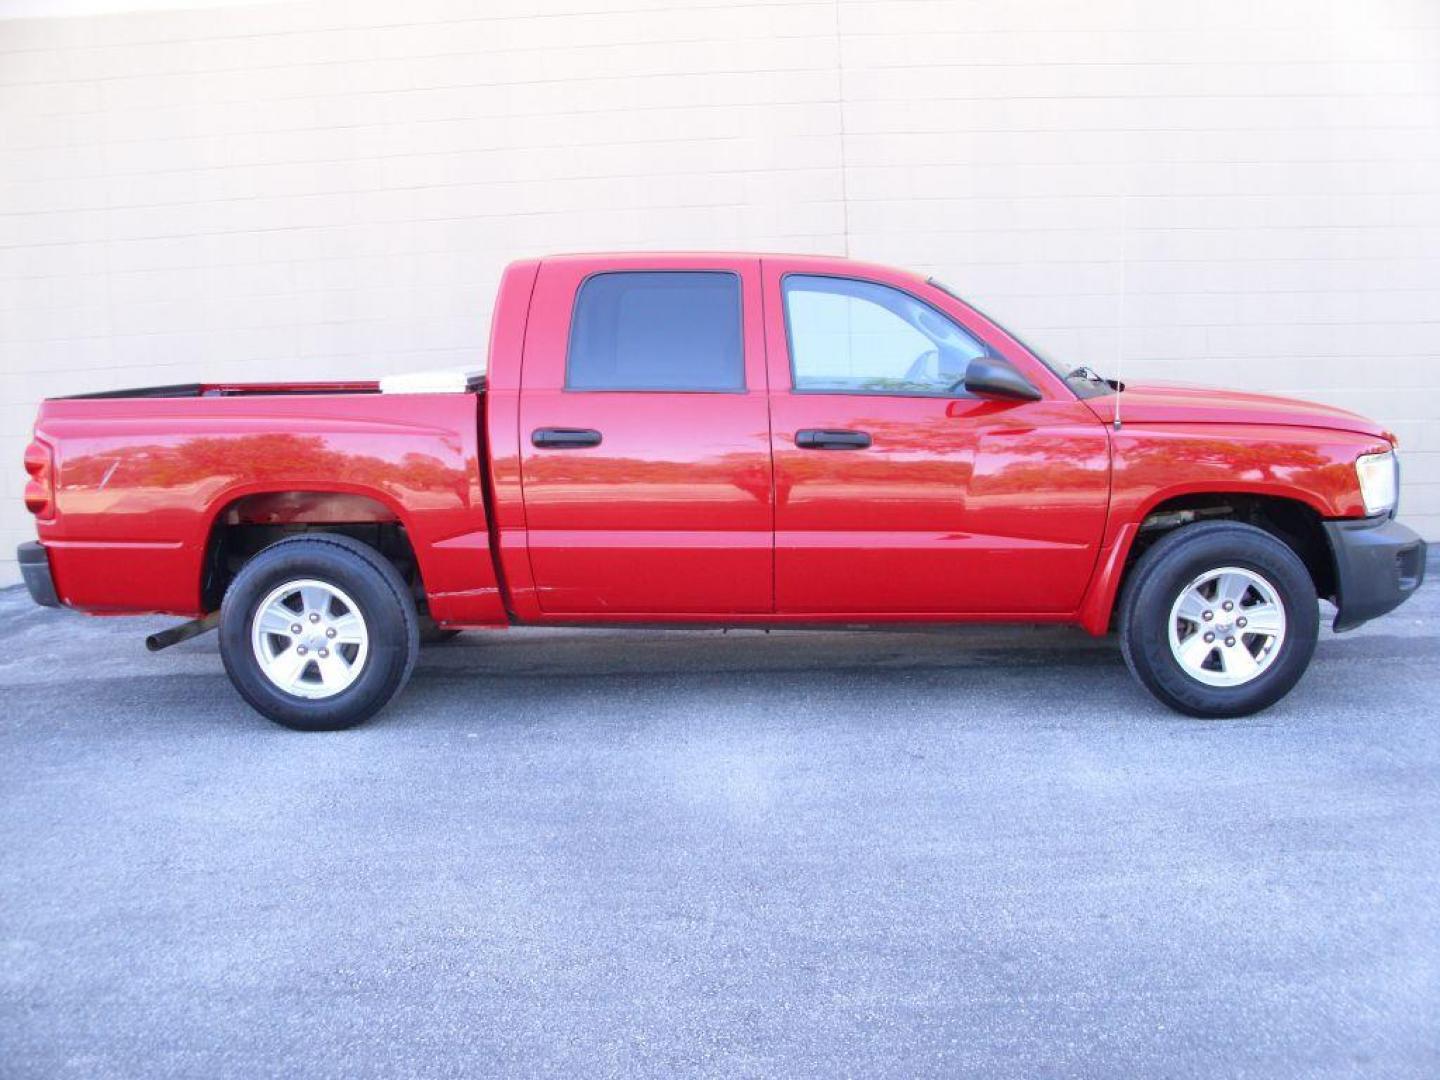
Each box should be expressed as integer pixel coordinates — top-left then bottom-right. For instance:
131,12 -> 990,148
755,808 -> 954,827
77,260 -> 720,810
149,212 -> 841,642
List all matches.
0,0 -> 1440,580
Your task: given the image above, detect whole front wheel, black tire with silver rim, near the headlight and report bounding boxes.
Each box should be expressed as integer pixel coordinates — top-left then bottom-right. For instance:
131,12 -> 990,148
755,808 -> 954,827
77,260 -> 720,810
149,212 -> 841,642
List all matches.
1119,521 -> 1320,717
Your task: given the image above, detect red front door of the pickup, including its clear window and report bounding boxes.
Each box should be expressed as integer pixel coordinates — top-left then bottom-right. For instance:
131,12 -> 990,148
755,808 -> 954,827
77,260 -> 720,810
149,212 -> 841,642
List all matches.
765,259 -> 1109,618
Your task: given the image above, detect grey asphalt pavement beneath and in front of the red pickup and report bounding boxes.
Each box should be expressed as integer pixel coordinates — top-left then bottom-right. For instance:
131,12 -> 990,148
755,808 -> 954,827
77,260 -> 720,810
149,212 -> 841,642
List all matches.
0,567 -> 1440,1077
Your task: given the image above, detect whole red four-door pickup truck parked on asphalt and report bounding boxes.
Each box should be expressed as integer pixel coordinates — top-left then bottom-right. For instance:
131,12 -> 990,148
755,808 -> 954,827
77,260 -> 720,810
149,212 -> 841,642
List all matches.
19,255 -> 1426,730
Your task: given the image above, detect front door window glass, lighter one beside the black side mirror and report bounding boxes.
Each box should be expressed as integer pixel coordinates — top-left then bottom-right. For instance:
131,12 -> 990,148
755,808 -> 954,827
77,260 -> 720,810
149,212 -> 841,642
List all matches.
783,274 -> 986,397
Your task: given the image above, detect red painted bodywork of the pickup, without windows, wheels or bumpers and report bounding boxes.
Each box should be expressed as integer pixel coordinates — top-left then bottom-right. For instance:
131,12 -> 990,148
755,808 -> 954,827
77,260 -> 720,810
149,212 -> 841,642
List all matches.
24,255 -> 1388,632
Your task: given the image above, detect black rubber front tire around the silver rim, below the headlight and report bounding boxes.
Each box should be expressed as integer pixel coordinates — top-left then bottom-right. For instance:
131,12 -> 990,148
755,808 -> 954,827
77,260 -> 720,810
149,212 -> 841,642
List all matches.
1119,521 -> 1320,717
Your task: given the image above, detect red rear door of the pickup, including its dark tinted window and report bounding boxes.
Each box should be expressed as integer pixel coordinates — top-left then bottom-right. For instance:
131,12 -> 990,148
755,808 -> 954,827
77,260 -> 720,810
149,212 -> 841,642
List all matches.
520,256 -> 775,621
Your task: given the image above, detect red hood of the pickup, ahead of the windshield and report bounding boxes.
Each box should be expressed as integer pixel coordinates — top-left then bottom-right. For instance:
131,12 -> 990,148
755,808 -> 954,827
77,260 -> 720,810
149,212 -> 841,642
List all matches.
1086,383 -> 1391,439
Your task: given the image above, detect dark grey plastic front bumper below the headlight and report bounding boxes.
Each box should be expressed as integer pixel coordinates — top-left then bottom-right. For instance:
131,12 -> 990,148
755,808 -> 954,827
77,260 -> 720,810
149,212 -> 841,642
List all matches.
1322,517 -> 1426,631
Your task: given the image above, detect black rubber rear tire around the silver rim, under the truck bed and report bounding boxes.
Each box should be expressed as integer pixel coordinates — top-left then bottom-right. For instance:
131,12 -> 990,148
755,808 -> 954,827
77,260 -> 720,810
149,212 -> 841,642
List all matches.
220,533 -> 419,732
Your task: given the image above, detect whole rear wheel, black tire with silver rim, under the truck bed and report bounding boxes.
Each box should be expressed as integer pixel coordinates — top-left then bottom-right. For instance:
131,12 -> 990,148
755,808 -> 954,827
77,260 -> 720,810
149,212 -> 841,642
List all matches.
220,534 -> 419,732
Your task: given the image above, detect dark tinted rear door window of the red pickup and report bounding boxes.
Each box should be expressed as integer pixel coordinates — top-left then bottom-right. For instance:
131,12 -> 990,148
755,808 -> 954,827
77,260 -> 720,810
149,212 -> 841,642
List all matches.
564,271 -> 744,390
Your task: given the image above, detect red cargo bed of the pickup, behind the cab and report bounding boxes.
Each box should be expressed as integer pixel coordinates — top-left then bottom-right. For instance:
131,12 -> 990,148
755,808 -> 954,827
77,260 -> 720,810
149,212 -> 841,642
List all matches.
23,382 -> 505,624
